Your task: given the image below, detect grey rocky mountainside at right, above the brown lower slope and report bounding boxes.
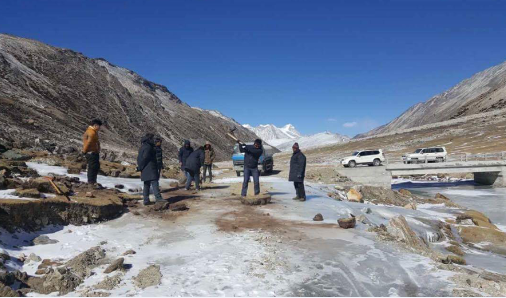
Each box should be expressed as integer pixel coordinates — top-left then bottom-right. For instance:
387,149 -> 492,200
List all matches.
356,62 -> 506,138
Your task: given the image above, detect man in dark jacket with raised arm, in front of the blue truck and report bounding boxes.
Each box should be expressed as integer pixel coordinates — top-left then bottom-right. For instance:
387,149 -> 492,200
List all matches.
238,139 -> 263,197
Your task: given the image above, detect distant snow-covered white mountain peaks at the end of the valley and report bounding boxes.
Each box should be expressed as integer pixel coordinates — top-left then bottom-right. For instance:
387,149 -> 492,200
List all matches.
243,124 -> 350,151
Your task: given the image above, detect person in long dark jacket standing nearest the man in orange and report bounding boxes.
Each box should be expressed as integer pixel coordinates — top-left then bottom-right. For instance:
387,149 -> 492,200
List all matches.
137,133 -> 163,206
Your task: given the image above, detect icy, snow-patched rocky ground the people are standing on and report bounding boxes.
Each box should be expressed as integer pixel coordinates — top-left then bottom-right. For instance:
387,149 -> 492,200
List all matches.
0,145 -> 506,296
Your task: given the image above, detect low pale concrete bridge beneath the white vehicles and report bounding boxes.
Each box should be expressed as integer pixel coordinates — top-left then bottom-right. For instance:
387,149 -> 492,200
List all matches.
338,160 -> 506,188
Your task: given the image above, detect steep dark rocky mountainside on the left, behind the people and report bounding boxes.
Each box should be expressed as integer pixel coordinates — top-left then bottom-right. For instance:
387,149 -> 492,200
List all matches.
0,34 -> 256,159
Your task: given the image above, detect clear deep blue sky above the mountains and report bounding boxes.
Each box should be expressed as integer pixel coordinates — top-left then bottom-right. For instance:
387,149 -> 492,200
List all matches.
0,0 -> 506,136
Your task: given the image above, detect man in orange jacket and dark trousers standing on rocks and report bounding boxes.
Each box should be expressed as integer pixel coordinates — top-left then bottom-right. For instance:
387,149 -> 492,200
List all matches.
83,119 -> 102,184
